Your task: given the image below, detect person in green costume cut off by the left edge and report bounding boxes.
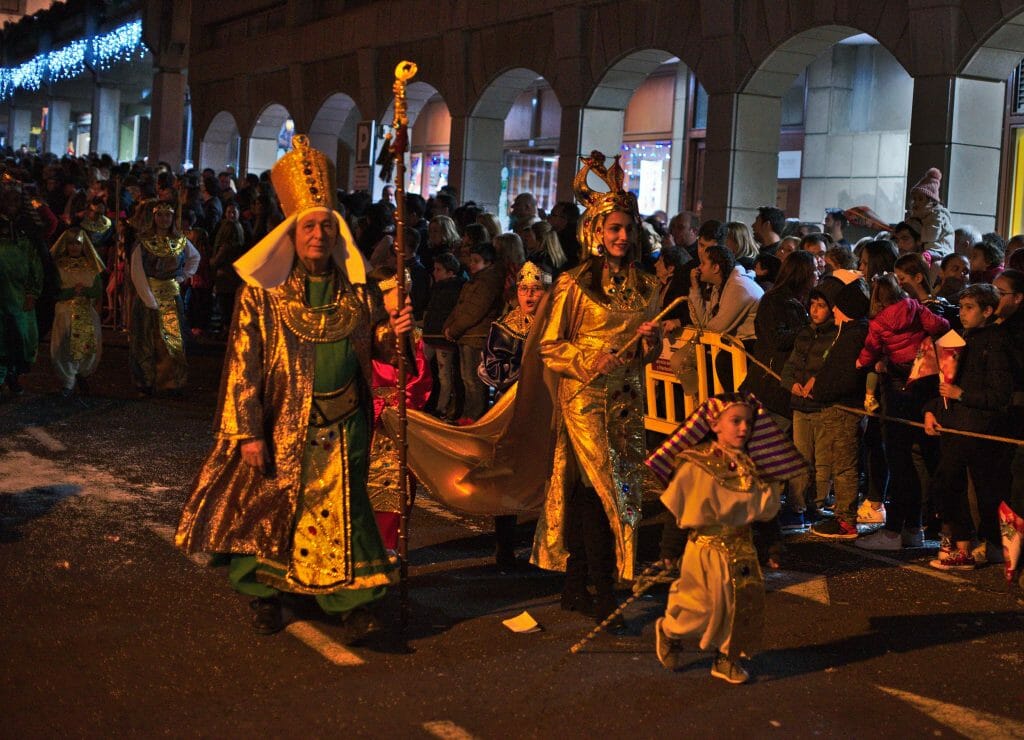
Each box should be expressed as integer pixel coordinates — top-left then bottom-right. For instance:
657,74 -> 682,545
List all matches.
0,180 -> 43,394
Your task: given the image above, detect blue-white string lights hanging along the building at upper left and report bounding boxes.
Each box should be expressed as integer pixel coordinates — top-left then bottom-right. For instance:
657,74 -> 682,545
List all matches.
0,20 -> 150,100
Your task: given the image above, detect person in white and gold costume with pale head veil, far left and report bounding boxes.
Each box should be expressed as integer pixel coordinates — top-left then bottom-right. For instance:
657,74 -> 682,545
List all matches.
50,228 -> 103,398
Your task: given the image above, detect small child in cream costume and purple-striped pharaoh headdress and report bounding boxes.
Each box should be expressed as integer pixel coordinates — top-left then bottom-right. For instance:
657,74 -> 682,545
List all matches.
647,393 -> 807,684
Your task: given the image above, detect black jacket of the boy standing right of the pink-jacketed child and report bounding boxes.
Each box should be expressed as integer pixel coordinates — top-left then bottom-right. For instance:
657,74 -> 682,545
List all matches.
925,323 -> 1014,434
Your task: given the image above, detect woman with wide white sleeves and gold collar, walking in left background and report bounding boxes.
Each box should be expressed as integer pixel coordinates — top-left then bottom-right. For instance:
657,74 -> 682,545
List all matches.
129,196 -> 200,395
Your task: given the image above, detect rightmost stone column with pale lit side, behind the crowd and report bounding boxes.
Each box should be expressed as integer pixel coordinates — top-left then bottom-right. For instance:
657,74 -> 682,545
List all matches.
906,75 -> 1006,232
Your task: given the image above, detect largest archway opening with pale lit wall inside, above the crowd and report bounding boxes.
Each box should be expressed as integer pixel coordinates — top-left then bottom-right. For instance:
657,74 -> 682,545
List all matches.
709,25 -> 913,222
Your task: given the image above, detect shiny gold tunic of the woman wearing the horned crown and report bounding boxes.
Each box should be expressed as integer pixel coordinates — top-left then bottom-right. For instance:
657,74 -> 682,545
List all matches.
531,263 -> 659,580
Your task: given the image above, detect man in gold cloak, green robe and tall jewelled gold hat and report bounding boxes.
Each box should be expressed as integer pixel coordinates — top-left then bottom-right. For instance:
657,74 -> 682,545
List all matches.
176,135 -> 412,641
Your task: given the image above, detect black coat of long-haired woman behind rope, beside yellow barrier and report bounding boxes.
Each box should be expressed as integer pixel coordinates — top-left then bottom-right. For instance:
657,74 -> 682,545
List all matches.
740,291 -> 811,417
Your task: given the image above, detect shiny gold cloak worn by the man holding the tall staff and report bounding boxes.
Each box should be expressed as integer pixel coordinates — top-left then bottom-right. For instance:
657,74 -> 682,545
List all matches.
175,270 -> 387,560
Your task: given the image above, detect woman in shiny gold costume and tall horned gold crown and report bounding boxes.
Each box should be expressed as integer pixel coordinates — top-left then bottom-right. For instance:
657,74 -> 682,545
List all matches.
531,151 -> 659,628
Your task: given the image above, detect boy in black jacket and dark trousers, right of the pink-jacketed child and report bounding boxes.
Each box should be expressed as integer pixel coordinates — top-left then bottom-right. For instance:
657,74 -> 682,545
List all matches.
925,284 -> 1014,570
